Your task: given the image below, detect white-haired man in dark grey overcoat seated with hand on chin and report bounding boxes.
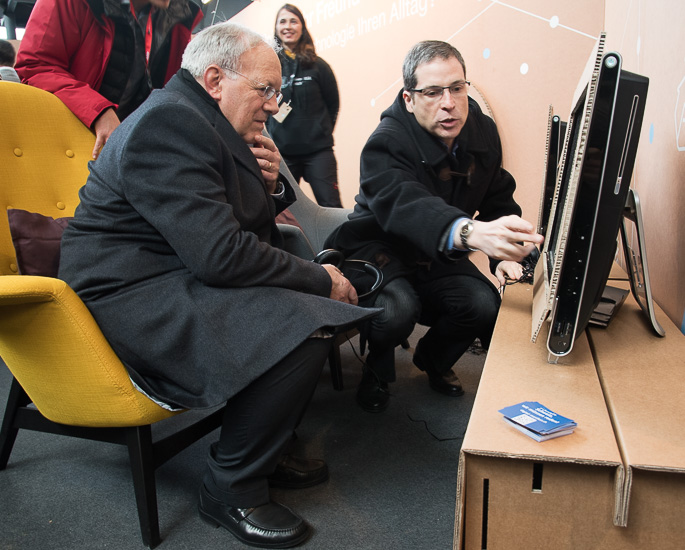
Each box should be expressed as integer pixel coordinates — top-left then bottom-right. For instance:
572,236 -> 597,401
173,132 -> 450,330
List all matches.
60,19 -> 375,548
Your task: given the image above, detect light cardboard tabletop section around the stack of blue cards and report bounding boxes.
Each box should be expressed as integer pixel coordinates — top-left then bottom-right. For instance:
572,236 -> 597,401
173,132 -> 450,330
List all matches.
462,285 -> 621,465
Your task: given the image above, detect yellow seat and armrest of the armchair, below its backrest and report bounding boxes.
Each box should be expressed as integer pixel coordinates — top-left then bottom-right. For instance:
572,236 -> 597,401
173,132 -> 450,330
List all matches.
0,275 -> 177,427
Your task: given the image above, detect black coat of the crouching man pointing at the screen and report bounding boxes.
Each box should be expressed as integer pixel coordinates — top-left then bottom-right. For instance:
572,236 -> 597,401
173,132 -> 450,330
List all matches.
326,92 -> 521,284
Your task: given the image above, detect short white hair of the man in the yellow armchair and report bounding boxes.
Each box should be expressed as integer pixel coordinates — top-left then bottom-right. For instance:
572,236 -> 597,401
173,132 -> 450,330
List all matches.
181,21 -> 278,78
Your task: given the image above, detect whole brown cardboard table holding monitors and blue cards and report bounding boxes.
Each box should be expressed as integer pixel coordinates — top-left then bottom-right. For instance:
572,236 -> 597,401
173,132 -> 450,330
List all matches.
454,285 -> 685,550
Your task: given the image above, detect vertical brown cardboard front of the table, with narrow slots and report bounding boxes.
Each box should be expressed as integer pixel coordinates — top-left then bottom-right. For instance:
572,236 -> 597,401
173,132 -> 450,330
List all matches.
454,455 -> 685,550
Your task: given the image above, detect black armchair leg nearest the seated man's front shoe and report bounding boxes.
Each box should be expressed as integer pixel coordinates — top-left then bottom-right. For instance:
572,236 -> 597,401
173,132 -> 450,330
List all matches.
126,425 -> 162,548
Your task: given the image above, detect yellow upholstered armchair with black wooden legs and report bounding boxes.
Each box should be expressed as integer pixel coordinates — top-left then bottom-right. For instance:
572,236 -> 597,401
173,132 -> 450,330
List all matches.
0,82 -> 223,548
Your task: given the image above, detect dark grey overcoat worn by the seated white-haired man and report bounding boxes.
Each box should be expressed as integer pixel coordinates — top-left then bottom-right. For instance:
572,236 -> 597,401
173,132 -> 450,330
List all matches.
60,70 -> 370,408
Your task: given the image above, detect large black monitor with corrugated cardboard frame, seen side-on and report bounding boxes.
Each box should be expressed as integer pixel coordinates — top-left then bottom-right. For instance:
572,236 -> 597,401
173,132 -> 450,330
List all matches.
532,35 -> 649,358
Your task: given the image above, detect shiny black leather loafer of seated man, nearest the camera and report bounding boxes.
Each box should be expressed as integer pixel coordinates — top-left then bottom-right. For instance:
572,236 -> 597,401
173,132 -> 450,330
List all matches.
198,485 -> 310,548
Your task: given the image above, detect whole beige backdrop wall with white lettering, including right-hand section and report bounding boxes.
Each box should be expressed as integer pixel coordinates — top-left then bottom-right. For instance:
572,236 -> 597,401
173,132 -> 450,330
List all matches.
234,0 -> 685,332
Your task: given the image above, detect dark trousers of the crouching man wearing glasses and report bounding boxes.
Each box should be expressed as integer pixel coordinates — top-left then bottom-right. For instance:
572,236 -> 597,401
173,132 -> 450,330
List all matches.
366,260 -> 501,382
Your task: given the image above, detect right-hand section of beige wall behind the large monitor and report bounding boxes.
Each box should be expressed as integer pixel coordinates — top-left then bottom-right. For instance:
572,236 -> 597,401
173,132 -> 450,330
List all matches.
606,0 -> 685,332
